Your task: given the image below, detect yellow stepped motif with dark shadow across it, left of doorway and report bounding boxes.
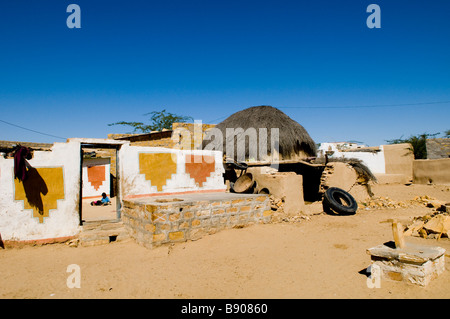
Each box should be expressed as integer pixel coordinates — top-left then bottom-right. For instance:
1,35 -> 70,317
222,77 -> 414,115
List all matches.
14,167 -> 64,223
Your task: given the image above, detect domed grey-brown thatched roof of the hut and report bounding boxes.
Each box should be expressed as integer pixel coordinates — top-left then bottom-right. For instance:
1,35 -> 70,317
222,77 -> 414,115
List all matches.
203,105 -> 316,161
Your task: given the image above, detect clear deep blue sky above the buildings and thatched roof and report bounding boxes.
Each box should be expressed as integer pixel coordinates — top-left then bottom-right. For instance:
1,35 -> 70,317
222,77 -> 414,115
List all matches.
0,0 -> 450,145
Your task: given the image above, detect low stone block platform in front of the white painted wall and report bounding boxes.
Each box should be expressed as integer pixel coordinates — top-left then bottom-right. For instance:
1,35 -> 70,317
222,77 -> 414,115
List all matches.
122,193 -> 272,248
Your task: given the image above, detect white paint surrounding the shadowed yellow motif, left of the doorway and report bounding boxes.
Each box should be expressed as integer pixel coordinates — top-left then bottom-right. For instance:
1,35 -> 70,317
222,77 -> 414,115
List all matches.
0,142 -> 80,241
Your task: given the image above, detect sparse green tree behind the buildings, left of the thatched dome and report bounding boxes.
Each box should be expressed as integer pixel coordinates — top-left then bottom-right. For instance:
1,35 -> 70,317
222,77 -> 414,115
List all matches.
108,110 -> 193,133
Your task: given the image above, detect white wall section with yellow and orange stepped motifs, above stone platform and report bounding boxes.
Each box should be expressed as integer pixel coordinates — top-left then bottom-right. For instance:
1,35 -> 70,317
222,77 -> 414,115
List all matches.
119,145 -> 226,199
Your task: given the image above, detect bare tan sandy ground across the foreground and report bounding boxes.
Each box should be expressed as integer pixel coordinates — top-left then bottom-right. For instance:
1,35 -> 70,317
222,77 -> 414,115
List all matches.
0,185 -> 450,299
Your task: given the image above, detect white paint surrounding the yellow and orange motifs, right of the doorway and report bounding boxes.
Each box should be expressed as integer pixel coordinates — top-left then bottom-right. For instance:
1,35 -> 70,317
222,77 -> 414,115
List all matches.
118,144 -> 226,199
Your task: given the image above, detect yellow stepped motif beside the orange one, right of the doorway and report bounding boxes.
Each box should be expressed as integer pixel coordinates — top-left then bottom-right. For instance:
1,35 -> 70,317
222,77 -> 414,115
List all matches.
139,153 -> 177,192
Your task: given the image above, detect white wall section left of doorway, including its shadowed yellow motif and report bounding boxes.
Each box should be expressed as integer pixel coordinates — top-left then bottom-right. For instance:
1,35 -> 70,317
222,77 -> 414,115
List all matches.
0,142 -> 81,241
